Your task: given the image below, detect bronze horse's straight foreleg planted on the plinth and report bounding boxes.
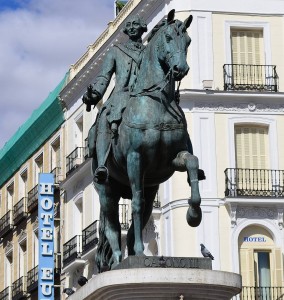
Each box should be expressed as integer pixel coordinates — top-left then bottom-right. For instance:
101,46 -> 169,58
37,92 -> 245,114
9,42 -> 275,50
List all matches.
127,152 -> 144,255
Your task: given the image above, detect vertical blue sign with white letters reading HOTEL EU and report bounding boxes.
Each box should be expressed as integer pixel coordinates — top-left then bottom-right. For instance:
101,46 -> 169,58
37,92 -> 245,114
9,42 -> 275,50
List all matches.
38,173 -> 54,300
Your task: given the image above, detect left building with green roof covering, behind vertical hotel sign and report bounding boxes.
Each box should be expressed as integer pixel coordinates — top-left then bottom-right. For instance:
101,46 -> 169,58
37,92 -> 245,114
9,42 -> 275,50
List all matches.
0,77 -> 66,300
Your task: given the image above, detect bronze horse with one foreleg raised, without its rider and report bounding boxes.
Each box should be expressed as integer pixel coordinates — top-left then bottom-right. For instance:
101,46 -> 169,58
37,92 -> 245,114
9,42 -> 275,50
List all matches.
93,10 -> 202,272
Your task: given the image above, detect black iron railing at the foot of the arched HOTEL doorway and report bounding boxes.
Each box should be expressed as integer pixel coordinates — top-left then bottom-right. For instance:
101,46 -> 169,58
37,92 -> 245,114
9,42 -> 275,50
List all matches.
233,286 -> 284,300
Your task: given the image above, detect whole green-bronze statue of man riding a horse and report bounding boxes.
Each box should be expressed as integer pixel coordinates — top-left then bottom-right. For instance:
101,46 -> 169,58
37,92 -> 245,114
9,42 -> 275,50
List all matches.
83,10 -> 205,272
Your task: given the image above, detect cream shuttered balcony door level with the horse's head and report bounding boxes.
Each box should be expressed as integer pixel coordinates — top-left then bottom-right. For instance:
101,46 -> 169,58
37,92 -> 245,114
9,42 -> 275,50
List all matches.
231,29 -> 265,89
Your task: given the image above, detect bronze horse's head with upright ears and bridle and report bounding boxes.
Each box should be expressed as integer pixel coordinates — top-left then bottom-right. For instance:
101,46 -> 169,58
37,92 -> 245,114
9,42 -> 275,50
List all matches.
158,10 -> 192,80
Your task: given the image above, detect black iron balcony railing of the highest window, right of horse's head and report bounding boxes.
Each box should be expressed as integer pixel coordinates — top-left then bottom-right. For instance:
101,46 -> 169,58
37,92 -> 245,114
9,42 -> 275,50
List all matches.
223,64 -> 278,92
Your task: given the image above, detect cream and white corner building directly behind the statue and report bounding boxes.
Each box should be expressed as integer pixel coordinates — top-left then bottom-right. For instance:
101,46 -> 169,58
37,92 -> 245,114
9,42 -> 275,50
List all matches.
60,0 -> 284,299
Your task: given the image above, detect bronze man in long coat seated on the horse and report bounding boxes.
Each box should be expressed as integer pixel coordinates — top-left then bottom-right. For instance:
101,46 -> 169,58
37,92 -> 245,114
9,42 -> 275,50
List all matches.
82,15 -> 147,183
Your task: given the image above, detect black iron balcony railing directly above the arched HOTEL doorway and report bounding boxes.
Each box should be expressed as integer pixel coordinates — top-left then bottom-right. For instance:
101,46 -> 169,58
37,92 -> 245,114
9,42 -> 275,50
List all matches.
225,168 -> 284,197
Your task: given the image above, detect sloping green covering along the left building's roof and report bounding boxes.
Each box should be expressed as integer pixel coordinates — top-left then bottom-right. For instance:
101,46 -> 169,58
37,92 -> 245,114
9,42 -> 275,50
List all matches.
0,72 -> 69,187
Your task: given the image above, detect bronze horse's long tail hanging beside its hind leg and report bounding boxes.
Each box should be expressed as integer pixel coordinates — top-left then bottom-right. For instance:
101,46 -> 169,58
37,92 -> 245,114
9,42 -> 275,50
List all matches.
96,212 -> 112,273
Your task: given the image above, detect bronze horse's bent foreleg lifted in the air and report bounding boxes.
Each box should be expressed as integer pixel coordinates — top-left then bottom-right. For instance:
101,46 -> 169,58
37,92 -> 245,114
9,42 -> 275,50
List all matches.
173,151 -> 202,227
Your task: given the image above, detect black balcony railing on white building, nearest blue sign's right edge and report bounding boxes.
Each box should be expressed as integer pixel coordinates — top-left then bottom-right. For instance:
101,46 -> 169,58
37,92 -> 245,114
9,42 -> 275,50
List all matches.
63,235 -> 82,267
